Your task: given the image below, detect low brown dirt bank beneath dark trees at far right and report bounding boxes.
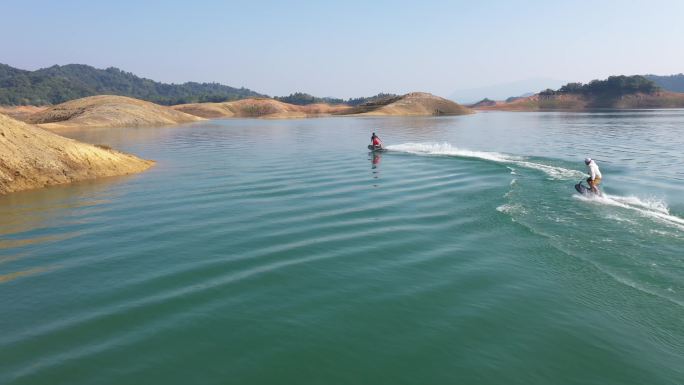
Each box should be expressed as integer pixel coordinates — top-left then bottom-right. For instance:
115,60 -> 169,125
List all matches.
473,91 -> 684,111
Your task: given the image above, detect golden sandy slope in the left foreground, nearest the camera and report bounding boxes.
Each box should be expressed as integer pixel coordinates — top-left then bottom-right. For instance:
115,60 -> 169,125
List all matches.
0,114 -> 154,194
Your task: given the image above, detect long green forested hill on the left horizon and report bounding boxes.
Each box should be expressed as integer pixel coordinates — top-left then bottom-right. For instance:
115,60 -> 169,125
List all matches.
0,64 -> 265,105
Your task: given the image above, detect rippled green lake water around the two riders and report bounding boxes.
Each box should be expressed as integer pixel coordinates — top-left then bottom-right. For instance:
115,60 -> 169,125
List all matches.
0,110 -> 684,385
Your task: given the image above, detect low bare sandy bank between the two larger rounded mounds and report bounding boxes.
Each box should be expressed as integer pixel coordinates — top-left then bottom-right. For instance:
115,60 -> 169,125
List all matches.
172,98 -> 349,119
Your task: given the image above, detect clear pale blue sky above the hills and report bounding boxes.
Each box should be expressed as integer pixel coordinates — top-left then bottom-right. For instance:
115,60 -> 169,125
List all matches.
0,0 -> 684,98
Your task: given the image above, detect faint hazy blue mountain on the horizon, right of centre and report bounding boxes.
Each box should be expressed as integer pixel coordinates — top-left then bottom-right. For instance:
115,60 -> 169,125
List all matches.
449,78 -> 566,104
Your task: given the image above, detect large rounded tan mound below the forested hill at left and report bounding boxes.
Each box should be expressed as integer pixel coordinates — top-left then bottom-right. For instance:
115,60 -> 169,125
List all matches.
27,95 -> 202,131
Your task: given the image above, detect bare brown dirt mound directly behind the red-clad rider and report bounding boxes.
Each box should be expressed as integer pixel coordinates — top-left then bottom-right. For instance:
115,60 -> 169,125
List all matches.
338,92 -> 474,116
